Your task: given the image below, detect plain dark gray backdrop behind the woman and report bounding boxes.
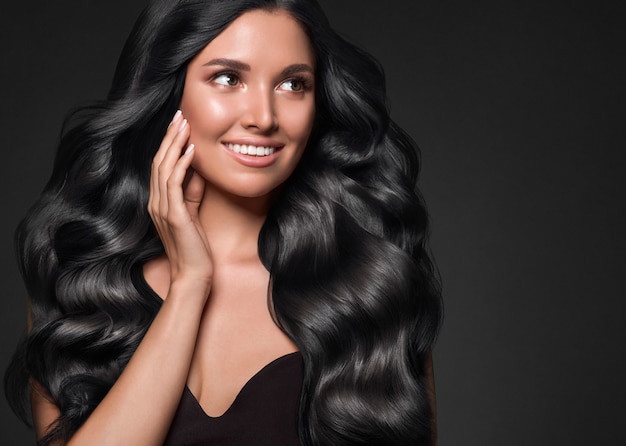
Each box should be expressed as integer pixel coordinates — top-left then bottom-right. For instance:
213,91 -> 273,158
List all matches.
0,0 -> 626,446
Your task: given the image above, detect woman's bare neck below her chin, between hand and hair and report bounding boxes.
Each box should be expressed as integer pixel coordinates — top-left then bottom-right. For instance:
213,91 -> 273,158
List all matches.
199,186 -> 271,264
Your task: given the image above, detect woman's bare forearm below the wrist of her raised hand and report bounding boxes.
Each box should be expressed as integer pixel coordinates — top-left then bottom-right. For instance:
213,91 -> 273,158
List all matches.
68,284 -> 208,446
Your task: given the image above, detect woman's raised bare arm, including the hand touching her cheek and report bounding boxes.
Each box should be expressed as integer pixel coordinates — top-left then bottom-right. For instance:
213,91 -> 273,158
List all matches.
48,112 -> 213,446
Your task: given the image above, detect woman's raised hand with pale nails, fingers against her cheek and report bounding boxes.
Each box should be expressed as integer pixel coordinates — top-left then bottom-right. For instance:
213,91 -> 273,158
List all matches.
148,110 -> 213,295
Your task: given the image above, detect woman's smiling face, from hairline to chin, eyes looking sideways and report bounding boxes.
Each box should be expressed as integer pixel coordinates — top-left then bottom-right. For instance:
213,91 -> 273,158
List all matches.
180,10 -> 315,197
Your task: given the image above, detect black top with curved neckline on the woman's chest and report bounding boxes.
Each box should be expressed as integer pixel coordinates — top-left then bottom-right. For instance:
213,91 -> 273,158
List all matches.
164,352 -> 302,446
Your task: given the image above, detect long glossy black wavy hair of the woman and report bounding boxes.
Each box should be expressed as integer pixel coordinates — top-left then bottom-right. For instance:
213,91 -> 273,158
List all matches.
5,0 -> 441,445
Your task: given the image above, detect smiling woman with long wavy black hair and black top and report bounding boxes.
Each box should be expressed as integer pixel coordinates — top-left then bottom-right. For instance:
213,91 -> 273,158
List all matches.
5,0 -> 440,445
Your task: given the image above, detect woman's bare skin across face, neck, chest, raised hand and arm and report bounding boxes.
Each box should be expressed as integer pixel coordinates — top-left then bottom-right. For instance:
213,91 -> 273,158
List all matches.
31,6 -> 434,446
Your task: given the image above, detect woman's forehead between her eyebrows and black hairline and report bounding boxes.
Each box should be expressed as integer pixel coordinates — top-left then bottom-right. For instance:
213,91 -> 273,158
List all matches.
192,10 -> 315,66
